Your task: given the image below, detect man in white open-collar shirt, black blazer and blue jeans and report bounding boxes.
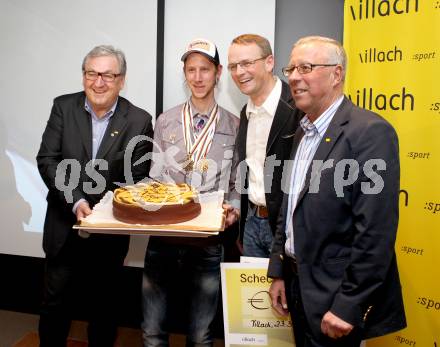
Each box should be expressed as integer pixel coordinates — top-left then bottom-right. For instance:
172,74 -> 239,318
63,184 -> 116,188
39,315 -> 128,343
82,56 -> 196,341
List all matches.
228,34 -> 300,257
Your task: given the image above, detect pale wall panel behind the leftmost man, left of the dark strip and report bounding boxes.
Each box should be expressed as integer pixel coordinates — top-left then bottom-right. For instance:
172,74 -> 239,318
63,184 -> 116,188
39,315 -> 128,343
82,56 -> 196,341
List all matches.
0,0 -> 157,256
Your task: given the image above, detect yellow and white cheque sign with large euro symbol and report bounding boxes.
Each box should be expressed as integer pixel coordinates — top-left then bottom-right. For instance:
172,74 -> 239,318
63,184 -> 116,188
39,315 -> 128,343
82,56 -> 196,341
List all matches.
221,263 -> 295,347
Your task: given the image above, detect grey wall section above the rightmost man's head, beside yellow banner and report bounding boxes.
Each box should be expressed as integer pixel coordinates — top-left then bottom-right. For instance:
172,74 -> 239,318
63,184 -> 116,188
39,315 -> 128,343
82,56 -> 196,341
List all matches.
274,0 -> 344,76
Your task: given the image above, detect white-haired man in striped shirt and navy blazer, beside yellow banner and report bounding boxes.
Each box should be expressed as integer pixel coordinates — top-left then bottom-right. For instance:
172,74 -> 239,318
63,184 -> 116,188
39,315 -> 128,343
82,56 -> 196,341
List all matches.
268,36 -> 406,347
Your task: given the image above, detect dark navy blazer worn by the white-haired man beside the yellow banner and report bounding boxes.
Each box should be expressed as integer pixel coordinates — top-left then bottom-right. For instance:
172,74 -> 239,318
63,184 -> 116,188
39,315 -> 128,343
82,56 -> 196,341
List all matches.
268,98 -> 406,338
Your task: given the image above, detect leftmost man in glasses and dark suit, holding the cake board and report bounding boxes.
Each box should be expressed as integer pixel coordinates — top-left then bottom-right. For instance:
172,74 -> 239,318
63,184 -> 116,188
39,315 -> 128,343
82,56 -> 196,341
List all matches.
37,46 -> 153,347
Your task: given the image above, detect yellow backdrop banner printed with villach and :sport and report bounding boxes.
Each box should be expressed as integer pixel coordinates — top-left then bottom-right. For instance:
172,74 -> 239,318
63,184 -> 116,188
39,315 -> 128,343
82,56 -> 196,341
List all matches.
344,0 -> 440,347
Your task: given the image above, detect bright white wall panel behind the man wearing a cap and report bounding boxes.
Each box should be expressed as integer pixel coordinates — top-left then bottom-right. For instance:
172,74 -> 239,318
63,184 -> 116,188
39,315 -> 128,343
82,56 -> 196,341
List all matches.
163,0 -> 275,115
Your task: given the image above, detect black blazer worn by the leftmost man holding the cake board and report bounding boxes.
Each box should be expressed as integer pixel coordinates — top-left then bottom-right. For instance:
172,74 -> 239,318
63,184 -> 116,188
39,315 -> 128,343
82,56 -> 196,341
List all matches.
37,92 -> 153,257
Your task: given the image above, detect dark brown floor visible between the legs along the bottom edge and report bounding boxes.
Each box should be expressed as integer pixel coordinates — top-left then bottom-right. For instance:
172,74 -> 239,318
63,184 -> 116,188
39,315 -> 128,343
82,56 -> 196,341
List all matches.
0,310 -> 224,347
